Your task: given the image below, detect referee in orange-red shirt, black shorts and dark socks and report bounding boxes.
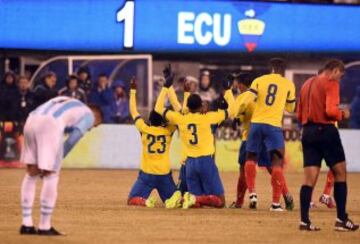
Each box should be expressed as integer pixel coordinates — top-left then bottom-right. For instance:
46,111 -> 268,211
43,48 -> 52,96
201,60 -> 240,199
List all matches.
298,60 -> 359,231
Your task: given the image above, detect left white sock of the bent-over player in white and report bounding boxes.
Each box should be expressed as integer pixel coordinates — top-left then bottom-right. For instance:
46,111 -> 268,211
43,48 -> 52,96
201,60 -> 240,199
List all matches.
21,174 -> 37,227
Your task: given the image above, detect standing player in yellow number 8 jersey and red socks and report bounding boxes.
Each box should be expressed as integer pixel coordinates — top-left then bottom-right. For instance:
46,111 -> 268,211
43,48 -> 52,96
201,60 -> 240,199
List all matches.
235,58 -> 295,211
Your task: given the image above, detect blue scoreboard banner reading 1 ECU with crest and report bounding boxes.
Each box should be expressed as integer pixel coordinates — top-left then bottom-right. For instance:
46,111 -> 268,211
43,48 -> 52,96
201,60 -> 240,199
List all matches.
0,0 -> 360,53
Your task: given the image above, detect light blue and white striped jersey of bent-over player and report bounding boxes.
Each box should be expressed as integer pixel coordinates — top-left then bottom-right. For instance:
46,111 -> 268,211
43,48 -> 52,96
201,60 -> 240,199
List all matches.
30,96 -> 95,134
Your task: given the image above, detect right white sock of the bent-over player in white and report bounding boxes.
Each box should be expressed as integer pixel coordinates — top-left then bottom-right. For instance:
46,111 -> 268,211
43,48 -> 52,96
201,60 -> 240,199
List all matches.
39,173 -> 59,230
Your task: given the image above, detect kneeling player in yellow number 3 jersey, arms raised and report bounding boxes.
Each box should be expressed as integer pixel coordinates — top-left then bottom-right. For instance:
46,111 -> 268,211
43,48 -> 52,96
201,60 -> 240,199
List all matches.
155,69 -> 232,209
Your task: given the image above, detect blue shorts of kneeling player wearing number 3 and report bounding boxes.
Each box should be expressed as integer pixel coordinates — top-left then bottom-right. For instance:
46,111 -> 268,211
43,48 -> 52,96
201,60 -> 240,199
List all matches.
186,156 -> 224,196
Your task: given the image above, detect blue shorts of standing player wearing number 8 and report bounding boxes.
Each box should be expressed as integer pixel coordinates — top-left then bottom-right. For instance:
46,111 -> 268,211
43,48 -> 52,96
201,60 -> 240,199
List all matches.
246,123 -> 285,154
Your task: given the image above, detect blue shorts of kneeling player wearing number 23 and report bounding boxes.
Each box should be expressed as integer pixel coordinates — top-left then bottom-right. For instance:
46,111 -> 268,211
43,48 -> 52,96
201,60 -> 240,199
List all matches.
129,171 -> 176,202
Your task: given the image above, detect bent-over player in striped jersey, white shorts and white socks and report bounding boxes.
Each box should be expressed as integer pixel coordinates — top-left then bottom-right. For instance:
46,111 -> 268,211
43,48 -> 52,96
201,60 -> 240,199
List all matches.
20,97 -> 101,235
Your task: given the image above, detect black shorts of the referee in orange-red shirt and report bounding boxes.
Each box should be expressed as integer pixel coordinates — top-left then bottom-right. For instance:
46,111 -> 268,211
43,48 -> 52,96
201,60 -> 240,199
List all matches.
301,124 -> 345,168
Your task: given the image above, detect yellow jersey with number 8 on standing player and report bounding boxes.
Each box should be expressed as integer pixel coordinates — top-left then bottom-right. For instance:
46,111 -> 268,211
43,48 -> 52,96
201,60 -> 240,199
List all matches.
239,74 -> 296,127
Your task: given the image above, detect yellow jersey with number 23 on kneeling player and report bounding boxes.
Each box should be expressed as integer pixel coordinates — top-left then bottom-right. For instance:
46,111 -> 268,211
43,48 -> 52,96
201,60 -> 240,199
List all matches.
130,90 -> 176,175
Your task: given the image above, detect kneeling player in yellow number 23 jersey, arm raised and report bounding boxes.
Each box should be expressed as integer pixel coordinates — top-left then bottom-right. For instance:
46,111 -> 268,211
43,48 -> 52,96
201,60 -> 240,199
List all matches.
128,79 -> 181,208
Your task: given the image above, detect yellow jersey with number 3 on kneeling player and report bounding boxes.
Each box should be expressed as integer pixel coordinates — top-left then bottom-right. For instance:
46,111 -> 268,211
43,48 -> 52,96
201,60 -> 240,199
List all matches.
155,88 -> 228,158
